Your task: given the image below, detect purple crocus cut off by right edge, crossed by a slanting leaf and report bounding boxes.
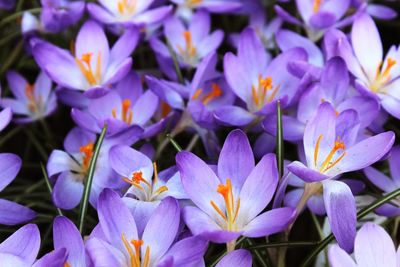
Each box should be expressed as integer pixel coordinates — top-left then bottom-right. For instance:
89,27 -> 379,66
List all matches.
364,146 -> 400,217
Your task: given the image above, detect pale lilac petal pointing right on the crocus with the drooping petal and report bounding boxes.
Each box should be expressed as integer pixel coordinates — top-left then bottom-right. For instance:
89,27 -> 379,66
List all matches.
334,132 -> 395,172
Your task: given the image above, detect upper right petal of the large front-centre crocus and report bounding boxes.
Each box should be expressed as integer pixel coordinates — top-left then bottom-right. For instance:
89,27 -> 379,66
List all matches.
238,154 -> 279,223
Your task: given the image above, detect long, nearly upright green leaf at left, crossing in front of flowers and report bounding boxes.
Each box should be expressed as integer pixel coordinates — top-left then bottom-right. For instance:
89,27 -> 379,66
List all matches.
79,124 -> 107,234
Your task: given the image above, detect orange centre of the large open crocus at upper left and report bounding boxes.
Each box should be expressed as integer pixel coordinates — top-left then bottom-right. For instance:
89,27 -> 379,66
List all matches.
75,52 -> 101,86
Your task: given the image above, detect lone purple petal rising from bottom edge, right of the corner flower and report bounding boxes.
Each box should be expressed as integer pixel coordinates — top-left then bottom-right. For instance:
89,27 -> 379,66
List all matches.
53,216 -> 86,267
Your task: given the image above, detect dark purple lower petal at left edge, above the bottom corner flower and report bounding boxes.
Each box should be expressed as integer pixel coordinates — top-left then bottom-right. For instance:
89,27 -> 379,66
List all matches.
0,199 -> 36,225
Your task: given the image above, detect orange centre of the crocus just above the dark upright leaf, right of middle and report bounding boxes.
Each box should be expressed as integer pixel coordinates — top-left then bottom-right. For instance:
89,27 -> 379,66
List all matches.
251,75 -> 281,109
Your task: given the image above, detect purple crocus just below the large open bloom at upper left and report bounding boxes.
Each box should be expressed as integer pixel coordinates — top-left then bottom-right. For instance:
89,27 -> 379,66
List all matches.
71,72 -> 167,137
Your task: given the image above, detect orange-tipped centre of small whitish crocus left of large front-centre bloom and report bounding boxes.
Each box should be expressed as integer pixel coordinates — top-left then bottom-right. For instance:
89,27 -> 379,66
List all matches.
122,162 -> 168,201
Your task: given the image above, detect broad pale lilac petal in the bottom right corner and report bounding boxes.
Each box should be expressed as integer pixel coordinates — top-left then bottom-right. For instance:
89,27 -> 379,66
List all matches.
354,223 -> 397,267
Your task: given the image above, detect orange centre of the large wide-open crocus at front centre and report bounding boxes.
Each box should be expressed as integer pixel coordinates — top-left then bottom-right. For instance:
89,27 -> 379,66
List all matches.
210,178 -> 240,231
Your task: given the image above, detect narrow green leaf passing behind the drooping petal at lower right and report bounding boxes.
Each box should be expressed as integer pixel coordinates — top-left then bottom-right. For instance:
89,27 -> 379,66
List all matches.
300,188 -> 400,267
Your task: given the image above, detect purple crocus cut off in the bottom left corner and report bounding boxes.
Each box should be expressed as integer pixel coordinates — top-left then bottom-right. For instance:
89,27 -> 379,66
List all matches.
0,224 -> 67,267
